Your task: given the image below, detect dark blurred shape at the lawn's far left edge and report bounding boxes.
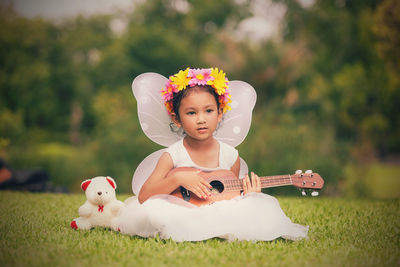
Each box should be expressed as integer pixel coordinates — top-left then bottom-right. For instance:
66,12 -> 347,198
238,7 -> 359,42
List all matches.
0,158 -> 68,193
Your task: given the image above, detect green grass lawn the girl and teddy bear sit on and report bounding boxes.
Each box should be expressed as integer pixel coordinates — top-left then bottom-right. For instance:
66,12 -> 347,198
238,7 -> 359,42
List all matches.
0,192 -> 400,266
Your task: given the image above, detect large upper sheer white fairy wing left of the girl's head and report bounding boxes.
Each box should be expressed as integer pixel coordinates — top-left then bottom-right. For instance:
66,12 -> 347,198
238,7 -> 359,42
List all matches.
132,72 -> 181,147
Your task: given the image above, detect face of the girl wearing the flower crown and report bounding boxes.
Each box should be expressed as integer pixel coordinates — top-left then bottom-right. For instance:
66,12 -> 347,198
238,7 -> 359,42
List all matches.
172,90 -> 223,141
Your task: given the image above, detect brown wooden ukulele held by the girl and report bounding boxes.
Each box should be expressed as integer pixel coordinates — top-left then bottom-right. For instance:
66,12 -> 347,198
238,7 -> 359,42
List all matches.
171,167 -> 324,206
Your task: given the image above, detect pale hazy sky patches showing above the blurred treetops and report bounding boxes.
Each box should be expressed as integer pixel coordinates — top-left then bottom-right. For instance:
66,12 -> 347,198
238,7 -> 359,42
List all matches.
0,0 -> 290,41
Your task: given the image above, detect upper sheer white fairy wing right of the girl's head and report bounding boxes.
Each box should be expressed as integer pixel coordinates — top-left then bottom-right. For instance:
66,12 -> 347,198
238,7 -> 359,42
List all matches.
215,81 -> 257,147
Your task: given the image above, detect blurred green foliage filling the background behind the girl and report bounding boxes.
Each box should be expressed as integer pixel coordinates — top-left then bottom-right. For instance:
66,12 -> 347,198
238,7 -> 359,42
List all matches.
0,0 -> 400,196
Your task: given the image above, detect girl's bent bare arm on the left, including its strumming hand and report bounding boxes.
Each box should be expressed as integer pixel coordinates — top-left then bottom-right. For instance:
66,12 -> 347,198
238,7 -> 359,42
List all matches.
138,153 -> 211,203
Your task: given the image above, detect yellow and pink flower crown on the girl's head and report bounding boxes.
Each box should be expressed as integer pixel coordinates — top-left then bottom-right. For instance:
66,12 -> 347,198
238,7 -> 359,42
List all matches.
161,68 -> 232,114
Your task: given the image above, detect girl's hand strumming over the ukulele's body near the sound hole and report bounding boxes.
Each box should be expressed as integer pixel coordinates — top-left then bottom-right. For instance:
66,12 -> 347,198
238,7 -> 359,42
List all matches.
174,171 -> 212,199
